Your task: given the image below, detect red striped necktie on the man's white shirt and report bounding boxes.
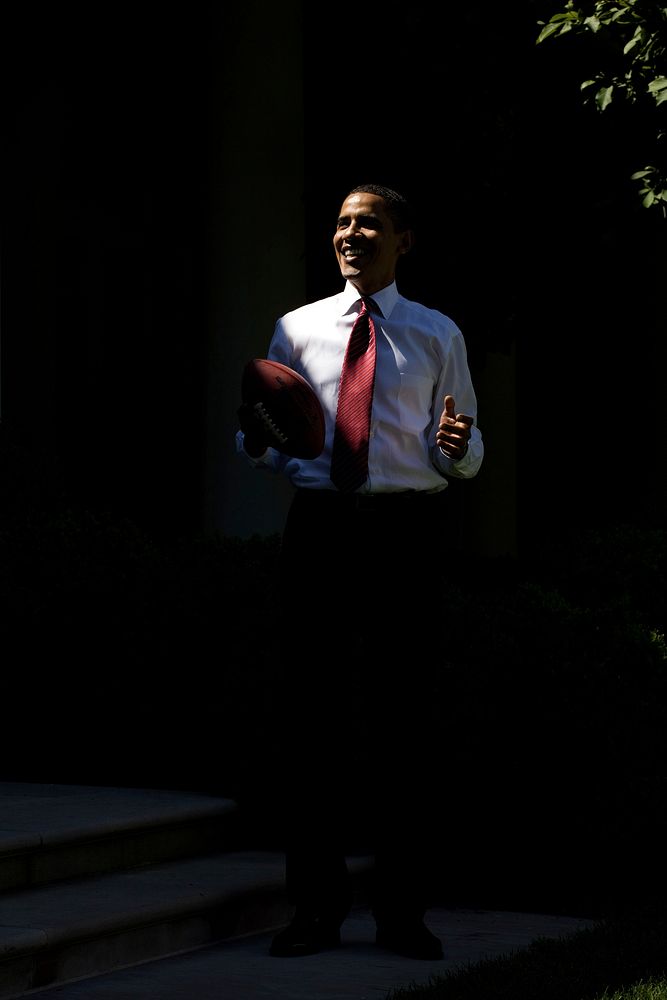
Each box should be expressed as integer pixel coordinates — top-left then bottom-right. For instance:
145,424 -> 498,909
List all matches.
330,298 -> 375,493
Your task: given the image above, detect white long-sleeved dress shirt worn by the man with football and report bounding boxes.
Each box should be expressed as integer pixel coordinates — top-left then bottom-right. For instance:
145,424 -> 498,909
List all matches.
237,282 -> 484,493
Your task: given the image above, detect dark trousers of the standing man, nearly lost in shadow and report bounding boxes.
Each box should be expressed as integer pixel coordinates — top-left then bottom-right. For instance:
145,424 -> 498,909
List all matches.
279,490 -> 447,923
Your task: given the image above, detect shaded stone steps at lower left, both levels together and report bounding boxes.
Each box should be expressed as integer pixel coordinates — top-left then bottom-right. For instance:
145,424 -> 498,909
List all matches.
0,782 -> 376,1000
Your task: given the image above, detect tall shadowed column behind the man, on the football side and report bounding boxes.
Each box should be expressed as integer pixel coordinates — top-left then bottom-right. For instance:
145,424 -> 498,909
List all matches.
202,0 -> 305,537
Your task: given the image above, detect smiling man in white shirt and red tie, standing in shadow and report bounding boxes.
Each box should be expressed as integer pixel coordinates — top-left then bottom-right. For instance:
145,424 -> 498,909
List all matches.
237,184 -> 484,959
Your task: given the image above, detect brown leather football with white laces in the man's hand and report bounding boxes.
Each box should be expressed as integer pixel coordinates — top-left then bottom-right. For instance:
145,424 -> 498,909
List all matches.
241,358 -> 325,458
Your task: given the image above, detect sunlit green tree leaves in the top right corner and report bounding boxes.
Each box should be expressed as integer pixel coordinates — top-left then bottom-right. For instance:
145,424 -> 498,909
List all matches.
537,0 -> 667,217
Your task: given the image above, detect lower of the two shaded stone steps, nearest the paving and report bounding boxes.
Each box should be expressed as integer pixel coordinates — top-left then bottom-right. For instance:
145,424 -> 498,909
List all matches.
0,852 -> 287,1000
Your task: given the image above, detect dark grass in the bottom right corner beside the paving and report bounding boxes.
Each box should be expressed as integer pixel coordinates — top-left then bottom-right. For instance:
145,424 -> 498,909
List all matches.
387,898 -> 667,1000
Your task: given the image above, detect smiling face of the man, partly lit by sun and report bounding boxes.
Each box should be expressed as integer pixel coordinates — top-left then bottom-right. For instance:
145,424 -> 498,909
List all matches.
333,192 -> 412,295
